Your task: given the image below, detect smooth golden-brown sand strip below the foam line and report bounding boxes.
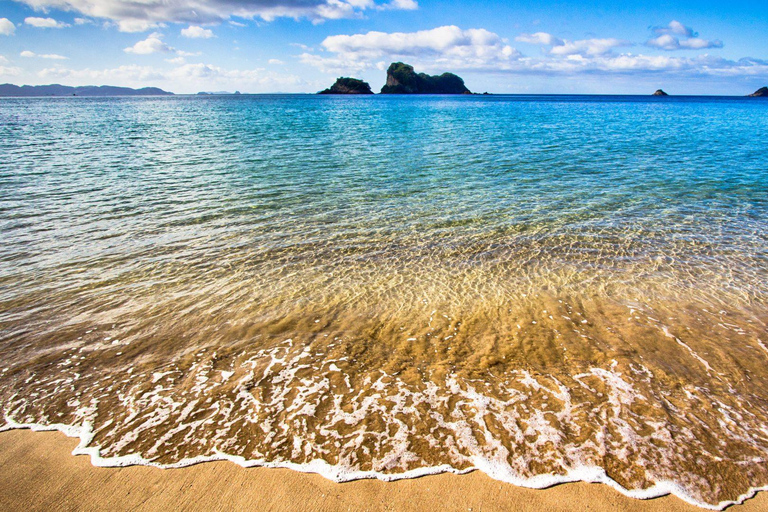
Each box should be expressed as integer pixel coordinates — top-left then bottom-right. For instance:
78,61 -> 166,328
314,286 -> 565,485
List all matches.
0,430 -> 768,512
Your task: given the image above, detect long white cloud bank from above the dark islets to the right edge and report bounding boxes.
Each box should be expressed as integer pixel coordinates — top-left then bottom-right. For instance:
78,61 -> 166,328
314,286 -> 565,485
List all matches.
306,25 -> 768,82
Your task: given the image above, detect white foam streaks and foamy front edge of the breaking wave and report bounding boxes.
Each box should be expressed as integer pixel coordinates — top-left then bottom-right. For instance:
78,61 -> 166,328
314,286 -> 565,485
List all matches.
0,340 -> 768,510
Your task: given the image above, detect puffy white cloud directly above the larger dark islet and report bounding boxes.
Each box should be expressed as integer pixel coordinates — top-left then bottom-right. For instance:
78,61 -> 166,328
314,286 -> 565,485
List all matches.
301,25 -> 519,72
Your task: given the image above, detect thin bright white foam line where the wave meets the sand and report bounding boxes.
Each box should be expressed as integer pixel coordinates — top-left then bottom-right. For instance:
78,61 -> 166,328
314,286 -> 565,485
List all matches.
0,415 -> 768,510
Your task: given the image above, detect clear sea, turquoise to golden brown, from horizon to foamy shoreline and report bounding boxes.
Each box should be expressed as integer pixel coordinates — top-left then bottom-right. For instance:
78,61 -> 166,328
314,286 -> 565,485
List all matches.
0,96 -> 768,506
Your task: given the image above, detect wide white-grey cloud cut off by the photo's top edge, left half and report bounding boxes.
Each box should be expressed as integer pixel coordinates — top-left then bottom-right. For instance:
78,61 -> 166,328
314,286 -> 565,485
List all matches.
10,0 -> 417,32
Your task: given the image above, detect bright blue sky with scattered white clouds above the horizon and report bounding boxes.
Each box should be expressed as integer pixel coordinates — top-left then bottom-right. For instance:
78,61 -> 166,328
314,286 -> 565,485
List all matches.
0,0 -> 768,95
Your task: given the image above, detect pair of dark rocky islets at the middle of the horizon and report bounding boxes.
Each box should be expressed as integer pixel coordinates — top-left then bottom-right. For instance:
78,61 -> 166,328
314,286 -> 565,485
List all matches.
318,62 -> 472,94
